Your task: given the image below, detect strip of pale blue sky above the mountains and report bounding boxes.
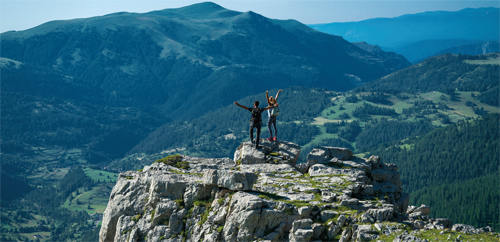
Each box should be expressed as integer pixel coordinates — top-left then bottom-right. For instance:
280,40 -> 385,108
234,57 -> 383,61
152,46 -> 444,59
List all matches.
0,0 -> 500,33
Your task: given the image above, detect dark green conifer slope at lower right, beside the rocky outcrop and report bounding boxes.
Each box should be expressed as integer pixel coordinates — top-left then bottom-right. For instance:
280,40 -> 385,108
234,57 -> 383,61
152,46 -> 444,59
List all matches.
370,114 -> 500,229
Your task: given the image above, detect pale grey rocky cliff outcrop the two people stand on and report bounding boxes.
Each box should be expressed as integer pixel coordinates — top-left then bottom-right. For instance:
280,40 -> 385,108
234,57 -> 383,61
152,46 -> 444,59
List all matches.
100,140 -> 492,241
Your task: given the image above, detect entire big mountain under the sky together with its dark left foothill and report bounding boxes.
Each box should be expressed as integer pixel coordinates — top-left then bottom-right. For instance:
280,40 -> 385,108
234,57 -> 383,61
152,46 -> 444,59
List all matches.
0,2 -> 410,162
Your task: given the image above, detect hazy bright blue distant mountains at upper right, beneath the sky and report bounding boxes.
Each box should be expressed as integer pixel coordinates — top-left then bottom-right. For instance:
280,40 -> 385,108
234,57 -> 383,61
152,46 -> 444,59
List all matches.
309,8 -> 500,63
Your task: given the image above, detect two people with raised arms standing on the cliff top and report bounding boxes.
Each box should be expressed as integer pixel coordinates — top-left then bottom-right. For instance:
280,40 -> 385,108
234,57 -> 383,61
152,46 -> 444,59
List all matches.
234,89 -> 283,149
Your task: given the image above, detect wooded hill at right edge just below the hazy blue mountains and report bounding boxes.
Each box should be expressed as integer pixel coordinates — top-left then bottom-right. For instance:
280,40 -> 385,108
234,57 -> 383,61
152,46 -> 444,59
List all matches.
358,53 -> 500,106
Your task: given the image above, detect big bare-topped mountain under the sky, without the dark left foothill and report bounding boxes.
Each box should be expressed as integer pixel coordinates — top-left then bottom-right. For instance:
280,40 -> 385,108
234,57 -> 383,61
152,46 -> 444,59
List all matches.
1,3 -> 409,119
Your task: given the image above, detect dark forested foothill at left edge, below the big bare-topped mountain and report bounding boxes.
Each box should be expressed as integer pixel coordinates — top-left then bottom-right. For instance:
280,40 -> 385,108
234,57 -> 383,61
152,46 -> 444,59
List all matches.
0,58 -> 169,164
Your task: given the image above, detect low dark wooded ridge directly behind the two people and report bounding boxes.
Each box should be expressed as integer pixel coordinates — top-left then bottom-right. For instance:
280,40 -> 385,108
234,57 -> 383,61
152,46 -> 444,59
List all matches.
129,87 -> 333,157
